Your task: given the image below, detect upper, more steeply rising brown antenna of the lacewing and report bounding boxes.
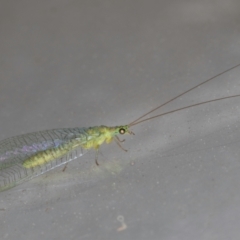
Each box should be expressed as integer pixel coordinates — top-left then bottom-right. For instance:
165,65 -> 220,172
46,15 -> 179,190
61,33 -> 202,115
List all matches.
129,64 -> 240,126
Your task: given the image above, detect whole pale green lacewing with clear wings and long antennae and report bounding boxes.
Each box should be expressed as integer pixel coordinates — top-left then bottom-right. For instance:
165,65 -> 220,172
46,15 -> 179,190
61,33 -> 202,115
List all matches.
0,64 -> 240,191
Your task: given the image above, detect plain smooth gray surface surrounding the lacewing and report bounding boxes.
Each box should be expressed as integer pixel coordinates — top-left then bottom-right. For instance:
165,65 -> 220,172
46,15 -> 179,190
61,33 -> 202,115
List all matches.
0,0 -> 240,240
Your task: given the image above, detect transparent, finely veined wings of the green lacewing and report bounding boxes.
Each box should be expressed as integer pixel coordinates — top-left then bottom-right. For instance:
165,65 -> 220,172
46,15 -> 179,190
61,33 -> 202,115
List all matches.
0,129 -> 87,191
